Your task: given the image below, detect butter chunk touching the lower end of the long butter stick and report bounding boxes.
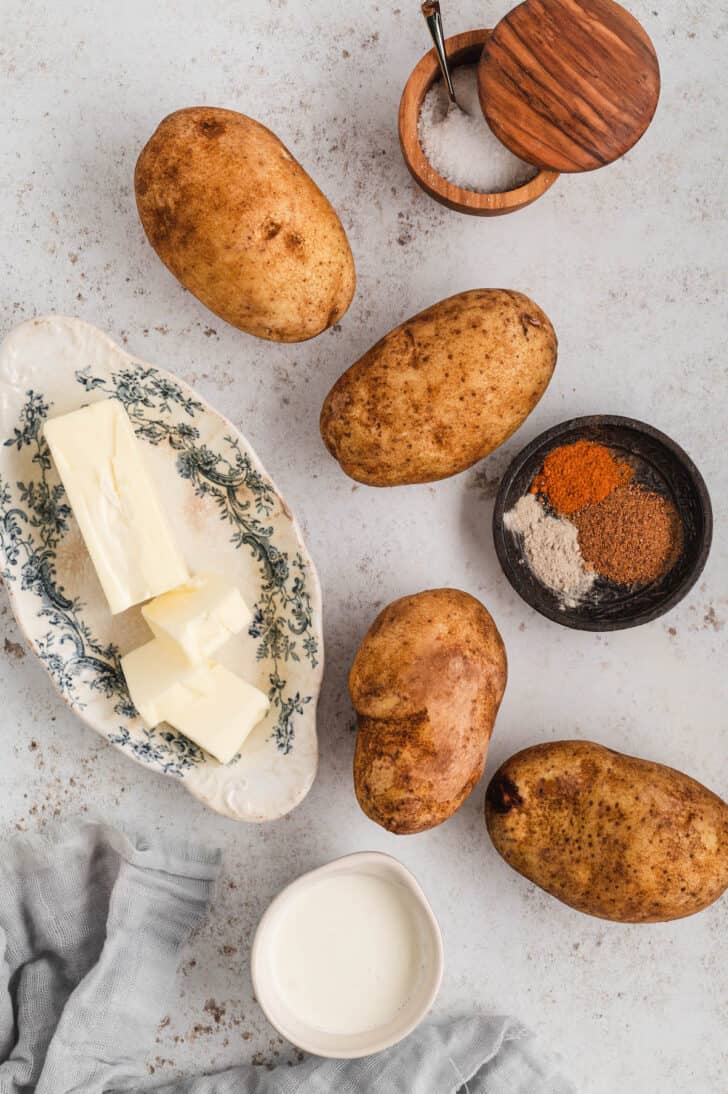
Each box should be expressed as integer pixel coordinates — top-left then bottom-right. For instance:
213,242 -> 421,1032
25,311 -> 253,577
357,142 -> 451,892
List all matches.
141,573 -> 253,665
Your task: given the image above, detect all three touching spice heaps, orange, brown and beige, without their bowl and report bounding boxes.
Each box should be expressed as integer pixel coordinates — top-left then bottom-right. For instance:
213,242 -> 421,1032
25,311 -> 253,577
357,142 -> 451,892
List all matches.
504,441 -> 683,607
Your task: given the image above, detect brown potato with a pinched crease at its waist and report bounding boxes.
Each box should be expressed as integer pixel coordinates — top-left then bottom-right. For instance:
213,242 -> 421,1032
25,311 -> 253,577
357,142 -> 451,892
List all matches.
349,589 -> 507,835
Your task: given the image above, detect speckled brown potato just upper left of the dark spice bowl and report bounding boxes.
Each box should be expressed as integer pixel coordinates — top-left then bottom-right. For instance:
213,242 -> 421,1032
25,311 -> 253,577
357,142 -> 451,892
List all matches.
321,289 -> 557,486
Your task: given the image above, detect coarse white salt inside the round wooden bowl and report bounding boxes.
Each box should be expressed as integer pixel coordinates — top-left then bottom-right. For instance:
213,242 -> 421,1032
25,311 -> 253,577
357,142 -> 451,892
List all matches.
418,65 -> 538,194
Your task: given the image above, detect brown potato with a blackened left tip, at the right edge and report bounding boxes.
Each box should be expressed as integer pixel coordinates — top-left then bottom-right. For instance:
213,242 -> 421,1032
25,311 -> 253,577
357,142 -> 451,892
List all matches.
485,741 -> 728,923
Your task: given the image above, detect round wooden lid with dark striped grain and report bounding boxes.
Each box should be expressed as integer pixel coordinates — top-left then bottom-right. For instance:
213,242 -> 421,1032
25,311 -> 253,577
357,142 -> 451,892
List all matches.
478,0 -> 660,172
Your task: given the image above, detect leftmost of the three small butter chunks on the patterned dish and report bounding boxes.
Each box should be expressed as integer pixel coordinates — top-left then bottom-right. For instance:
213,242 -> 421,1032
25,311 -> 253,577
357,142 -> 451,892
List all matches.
122,639 -> 209,729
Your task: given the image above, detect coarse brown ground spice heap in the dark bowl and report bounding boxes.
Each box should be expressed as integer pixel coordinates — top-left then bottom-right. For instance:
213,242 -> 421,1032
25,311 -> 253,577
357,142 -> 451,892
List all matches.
574,486 -> 683,585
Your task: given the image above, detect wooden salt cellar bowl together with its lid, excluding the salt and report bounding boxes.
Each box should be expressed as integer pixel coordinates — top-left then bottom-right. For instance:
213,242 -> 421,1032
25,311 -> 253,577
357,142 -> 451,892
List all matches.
400,0 -> 660,217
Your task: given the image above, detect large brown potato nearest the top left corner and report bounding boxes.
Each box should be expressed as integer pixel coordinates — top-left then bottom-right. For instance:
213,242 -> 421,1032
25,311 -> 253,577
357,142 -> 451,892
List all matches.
135,106 -> 356,342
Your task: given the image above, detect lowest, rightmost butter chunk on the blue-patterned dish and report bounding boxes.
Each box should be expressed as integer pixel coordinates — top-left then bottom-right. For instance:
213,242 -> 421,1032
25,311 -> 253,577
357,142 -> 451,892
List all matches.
161,665 -> 270,764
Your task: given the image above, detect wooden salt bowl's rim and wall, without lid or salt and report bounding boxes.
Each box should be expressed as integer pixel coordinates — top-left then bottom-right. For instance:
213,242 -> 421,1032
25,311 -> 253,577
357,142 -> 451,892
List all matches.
400,28 -> 558,217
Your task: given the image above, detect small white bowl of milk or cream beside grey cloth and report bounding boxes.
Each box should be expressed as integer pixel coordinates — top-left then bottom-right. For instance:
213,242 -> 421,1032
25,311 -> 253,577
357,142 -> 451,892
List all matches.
251,851 -> 444,1059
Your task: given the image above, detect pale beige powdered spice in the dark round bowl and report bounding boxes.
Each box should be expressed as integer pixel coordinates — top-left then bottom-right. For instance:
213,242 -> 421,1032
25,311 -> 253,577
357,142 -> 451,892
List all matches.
504,493 -> 597,608
